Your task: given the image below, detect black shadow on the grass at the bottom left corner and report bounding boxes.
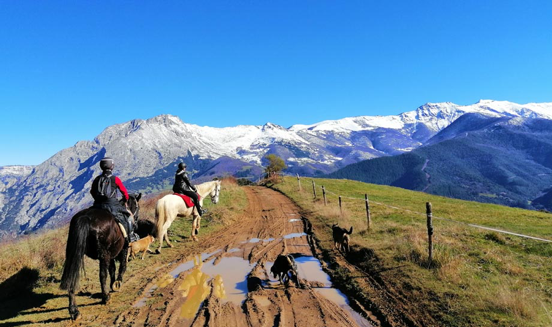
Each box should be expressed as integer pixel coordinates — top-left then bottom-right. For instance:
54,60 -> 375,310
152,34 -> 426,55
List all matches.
0,267 -> 60,326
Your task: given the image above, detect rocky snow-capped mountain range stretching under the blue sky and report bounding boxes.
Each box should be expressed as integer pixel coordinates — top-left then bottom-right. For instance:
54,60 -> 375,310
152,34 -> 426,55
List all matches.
0,100 -> 552,238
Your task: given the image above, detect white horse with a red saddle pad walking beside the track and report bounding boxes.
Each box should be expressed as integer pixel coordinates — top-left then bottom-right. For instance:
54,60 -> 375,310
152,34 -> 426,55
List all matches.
155,180 -> 221,253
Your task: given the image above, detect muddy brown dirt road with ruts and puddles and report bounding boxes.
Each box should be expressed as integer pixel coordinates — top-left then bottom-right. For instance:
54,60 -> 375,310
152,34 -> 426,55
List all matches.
115,187 -> 370,327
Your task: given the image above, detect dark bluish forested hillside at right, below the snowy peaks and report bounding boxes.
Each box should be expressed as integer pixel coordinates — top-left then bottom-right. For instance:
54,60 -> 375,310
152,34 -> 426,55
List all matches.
327,114 -> 552,210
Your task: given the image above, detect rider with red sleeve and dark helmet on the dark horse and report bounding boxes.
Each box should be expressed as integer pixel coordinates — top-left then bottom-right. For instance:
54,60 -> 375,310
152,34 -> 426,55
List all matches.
90,157 -> 139,243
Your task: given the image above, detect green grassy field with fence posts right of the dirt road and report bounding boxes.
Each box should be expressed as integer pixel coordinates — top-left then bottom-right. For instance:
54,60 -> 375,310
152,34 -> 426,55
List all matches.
272,177 -> 552,326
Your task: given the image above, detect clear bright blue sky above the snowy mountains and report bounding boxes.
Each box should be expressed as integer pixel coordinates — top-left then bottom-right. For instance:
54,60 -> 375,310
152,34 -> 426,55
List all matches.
0,0 -> 552,166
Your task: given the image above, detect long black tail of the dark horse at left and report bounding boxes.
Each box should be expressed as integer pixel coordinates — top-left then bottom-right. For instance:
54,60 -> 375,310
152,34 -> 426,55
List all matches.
60,215 -> 90,291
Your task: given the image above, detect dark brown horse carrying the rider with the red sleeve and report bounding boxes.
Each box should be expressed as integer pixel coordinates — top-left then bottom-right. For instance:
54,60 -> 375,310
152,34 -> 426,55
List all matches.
60,193 -> 142,320
